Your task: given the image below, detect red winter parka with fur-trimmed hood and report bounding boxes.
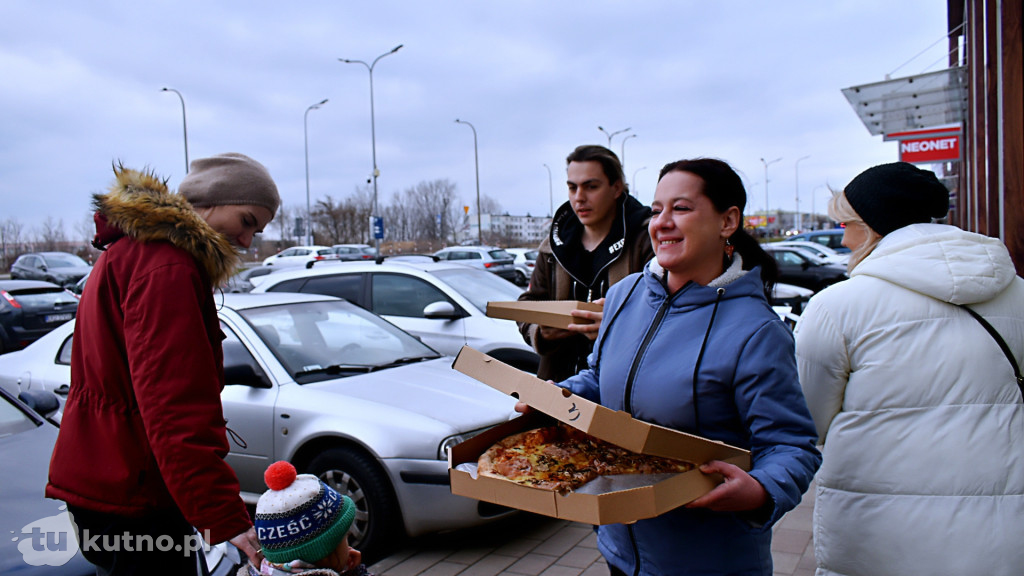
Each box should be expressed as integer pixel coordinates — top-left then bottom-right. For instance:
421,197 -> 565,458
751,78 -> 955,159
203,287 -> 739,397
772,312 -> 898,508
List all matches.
46,169 -> 251,543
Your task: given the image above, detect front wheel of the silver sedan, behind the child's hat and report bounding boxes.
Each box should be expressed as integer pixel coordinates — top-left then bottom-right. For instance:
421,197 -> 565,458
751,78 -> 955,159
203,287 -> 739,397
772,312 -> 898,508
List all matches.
308,447 -> 403,564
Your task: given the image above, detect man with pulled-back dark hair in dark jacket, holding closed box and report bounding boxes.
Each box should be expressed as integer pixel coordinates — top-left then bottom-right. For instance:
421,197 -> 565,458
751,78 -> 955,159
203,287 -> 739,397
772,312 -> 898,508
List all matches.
519,145 -> 654,381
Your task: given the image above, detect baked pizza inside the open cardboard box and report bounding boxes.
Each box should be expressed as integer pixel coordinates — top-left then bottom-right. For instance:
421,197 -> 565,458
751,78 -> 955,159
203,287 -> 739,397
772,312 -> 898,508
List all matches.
477,424 -> 694,494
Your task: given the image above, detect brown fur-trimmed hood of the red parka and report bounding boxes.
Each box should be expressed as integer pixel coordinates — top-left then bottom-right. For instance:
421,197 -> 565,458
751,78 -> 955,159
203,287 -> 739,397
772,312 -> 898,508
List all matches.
92,164 -> 239,286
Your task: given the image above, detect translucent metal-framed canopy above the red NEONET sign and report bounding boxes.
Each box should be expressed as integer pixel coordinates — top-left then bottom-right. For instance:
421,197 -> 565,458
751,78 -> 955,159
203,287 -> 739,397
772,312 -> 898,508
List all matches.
843,67 -> 967,135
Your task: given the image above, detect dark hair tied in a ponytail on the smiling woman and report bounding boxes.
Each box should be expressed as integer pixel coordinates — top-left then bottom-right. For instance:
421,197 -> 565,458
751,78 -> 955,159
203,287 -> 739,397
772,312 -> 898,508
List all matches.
657,158 -> 778,301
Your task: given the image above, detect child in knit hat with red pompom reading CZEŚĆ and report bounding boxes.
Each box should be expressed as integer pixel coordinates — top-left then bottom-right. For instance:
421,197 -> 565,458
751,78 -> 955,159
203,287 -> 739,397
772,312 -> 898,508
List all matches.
238,461 -> 373,576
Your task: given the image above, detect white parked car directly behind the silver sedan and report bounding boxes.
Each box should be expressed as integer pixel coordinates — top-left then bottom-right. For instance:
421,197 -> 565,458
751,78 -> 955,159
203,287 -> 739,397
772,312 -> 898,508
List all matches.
253,258 -> 540,372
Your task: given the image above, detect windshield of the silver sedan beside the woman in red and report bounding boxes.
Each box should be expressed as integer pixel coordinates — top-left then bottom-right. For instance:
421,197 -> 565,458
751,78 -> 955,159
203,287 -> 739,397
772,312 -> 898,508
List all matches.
239,297 -> 442,383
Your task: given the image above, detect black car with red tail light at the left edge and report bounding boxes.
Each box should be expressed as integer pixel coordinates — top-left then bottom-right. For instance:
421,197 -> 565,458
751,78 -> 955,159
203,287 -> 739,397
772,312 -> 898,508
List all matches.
0,280 -> 78,354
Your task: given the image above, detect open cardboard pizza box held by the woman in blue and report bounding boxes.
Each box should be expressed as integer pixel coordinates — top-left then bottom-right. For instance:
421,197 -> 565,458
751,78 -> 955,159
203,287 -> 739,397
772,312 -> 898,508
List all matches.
449,346 -> 751,525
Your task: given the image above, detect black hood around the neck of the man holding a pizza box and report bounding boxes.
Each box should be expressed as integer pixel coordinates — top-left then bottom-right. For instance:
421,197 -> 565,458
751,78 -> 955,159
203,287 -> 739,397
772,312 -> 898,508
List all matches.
547,192 -> 650,265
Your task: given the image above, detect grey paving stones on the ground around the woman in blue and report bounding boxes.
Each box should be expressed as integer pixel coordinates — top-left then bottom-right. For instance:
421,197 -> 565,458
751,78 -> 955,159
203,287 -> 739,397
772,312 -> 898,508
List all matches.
370,485 -> 814,576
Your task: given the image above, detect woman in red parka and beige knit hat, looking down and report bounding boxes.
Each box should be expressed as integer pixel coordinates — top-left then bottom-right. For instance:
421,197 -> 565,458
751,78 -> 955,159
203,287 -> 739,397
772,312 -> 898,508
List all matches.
46,154 -> 281,574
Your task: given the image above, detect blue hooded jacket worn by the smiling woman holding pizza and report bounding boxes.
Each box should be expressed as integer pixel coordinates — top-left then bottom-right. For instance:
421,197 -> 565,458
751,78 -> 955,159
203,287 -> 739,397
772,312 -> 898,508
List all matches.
560,255 -> 821,575
